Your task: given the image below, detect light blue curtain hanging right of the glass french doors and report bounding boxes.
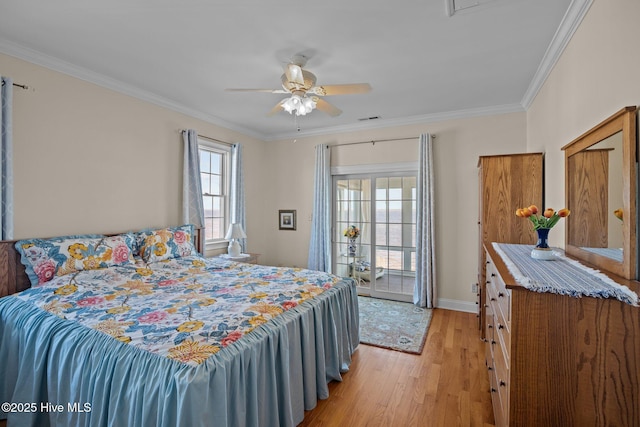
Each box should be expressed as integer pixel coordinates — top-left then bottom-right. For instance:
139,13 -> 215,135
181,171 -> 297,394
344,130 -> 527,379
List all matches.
413,134 -> 436,308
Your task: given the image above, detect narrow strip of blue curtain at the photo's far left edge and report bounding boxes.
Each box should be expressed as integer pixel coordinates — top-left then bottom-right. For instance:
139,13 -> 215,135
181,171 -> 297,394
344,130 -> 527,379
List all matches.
0,77 -> 13,240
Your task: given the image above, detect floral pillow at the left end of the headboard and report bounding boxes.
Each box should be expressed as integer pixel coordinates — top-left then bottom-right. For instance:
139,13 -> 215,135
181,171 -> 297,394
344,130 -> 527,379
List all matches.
16,233 -> 135,286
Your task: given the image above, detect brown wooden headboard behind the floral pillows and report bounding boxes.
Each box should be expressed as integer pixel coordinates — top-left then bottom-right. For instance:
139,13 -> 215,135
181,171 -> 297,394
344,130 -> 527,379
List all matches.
0,228 -> 204,298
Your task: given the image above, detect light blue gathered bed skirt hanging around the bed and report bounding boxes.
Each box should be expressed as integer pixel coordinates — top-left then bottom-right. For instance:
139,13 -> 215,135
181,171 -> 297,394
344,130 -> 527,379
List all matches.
0,279 -> 359,427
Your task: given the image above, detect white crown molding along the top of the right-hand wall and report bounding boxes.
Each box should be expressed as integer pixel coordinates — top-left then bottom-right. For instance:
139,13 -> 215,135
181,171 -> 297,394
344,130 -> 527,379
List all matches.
522,0 -> 593,110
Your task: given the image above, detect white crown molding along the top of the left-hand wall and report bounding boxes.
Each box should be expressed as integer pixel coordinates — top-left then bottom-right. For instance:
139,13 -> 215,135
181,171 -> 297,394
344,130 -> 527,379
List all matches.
0,38 -> 265,140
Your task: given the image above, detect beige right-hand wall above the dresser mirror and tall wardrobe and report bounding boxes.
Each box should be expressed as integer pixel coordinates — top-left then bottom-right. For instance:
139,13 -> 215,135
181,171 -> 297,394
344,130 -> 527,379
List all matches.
527,0 -> 640,247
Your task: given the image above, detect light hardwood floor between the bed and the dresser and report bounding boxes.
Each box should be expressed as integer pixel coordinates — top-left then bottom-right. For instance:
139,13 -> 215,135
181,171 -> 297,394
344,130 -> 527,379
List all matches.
300,309 -> 494,427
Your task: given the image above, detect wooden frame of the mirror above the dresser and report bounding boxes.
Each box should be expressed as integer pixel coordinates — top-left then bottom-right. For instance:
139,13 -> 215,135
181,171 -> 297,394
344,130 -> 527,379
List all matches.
562,106 -> 637,280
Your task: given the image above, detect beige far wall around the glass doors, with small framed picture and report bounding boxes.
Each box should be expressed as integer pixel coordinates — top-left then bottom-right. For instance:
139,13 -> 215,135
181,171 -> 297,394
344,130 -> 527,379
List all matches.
265,113 -> 526,310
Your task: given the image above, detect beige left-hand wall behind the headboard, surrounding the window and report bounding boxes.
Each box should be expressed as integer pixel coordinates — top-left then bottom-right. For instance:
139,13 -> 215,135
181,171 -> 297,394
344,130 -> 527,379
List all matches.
0,54 -> 266,251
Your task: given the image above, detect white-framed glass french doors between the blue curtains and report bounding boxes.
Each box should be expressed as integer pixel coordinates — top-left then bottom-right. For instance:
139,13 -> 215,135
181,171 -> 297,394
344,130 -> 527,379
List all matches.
332,173 -> 417,301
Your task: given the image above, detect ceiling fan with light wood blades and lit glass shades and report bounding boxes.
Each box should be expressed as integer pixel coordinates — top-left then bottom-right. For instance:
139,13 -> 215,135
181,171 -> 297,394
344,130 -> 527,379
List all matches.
225,54 -> 371,117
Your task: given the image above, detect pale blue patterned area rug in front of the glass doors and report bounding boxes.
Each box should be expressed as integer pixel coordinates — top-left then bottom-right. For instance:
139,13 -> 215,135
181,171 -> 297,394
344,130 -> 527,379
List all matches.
358,296 -> 432,354
